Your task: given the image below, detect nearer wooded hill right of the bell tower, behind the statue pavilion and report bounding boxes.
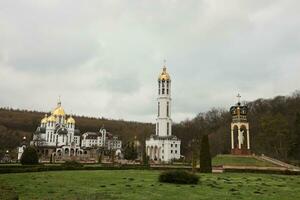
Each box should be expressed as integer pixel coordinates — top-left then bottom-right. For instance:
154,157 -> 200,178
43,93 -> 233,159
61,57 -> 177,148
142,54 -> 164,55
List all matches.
173,92 -> 300,163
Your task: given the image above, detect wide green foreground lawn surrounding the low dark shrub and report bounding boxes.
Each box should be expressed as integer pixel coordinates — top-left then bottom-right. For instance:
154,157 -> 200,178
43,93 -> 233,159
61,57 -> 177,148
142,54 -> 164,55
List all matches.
0,170 -> 300,200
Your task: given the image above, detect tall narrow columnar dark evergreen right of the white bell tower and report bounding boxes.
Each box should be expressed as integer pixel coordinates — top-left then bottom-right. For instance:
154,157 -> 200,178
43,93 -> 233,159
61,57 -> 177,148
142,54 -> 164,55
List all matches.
200,135 -> 212,173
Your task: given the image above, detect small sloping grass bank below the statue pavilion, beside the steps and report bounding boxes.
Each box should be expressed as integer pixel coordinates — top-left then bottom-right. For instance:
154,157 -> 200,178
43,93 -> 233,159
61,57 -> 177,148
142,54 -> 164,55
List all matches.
212,155 -> 278,167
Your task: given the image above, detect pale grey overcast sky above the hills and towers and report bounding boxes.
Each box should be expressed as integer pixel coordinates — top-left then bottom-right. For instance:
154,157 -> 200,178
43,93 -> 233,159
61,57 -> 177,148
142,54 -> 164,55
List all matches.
0,0 -> 300,122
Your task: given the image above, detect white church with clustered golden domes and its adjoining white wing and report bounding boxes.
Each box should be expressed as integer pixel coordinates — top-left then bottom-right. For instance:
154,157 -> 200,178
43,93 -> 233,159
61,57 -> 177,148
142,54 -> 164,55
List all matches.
18,100 -> 122,160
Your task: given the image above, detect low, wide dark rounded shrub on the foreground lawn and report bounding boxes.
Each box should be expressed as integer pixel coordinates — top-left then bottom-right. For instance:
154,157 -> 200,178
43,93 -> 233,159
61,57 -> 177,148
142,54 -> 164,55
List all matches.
159,170 -> 199,184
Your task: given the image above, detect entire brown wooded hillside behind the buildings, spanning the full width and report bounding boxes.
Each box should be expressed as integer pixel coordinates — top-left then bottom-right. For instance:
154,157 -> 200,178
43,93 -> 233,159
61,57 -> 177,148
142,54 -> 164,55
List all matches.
0,92 -> 300,164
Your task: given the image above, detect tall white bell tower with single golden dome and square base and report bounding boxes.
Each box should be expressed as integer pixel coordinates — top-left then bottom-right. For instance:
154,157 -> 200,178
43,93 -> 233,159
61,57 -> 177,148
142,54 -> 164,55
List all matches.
146,66 -> 181,162
